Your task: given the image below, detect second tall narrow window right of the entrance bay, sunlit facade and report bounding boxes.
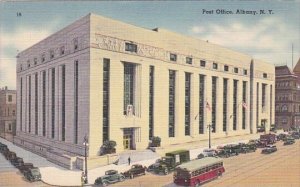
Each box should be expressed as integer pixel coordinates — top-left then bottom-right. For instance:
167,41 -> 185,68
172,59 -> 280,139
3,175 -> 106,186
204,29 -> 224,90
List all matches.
169,70 -> 176,137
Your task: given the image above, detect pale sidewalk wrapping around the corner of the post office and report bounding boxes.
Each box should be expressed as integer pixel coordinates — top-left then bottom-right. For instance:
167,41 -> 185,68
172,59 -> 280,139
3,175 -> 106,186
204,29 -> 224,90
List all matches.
0,134 -> 260,186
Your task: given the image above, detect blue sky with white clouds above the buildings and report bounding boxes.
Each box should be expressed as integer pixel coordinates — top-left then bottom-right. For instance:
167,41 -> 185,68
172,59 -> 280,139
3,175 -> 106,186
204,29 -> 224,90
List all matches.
0,1 -> 300,89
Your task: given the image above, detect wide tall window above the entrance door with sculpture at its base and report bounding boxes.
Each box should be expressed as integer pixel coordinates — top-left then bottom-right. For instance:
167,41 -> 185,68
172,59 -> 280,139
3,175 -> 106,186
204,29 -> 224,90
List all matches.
124,63 -> 135,115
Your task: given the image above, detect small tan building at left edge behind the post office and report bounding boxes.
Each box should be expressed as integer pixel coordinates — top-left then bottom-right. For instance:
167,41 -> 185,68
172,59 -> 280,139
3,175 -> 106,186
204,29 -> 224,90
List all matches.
0,87 -> 17,141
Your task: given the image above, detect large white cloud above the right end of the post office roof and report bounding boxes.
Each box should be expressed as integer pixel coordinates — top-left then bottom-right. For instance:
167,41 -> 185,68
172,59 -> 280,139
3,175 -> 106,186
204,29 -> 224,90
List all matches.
190,17 -> 300,65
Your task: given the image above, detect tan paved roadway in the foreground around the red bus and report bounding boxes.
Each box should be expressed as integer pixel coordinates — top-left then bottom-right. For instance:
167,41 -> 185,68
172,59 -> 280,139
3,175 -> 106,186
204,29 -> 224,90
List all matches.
112,140 -> 300,187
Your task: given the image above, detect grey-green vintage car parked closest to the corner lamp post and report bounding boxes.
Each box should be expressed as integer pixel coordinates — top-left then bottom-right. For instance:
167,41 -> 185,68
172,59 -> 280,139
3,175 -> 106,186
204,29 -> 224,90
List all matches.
94,170 -> 125,186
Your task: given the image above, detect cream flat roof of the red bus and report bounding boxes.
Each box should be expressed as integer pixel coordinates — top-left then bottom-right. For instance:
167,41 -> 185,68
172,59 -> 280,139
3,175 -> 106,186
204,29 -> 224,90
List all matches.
177,157 -> 223,171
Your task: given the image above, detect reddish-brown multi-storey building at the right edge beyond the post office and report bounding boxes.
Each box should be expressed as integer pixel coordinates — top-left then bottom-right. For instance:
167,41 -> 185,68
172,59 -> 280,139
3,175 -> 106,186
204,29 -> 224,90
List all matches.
275,60 -> 300,130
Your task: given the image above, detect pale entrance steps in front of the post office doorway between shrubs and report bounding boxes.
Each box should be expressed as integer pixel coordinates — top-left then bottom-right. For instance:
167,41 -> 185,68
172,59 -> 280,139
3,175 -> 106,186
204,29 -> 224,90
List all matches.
115,149 -> 160,165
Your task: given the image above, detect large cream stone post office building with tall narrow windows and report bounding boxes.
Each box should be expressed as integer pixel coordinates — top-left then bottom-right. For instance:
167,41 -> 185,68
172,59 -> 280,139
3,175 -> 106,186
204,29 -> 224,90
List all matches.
15,14 -> 275,164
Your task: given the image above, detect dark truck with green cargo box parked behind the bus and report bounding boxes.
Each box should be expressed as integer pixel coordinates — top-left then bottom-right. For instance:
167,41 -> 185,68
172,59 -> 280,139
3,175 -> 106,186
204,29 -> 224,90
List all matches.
153,150 -> 190,175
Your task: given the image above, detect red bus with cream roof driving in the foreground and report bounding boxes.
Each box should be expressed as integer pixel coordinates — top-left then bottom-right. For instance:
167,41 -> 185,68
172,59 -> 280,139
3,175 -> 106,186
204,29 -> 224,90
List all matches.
174,157 -> 225,186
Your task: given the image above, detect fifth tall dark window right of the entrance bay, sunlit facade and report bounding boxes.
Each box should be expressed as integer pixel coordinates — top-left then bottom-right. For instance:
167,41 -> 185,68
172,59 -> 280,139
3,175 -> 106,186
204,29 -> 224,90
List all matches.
211,77 -> 217,132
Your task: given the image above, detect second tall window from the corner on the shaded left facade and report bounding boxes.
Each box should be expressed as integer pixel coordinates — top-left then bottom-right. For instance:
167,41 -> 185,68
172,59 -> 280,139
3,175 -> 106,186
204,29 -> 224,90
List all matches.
61,65 -> 66,141
